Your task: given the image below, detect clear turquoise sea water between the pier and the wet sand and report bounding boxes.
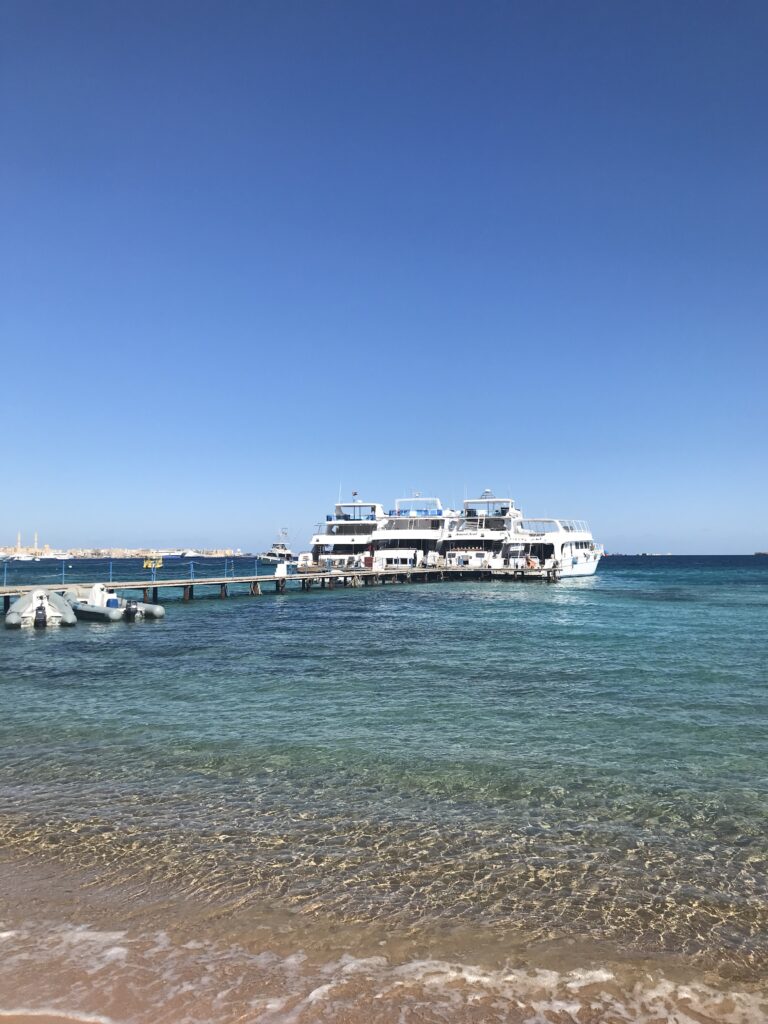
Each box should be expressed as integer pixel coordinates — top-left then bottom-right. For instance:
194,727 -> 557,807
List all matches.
0,557 -> 768,1019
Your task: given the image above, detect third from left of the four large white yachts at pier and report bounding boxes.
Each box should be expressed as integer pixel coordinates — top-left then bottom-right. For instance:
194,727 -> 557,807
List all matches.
440,490 -> 522,569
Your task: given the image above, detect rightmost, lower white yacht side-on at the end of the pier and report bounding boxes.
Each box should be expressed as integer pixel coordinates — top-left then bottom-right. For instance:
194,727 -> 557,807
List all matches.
502,519 -> 604,579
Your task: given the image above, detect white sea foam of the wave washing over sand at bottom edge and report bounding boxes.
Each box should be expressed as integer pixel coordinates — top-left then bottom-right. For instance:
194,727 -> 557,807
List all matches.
0,926 -> 768,1024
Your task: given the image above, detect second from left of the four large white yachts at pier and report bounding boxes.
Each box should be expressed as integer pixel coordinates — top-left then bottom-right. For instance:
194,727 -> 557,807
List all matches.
373,494 -> 459,569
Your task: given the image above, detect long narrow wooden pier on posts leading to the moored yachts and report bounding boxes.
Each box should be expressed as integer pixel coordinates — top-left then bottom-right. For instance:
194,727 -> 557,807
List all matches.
0,566 -> 559,611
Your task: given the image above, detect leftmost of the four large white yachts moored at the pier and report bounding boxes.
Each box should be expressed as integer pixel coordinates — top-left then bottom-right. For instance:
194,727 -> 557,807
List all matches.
299,497 -> 386,569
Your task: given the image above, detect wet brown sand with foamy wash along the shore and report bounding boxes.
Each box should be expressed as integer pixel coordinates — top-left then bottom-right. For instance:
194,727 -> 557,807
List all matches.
0,858 -> 768,1024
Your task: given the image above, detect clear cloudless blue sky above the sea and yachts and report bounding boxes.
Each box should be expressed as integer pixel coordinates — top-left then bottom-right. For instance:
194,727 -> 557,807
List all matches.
0,0 -> 768,553
